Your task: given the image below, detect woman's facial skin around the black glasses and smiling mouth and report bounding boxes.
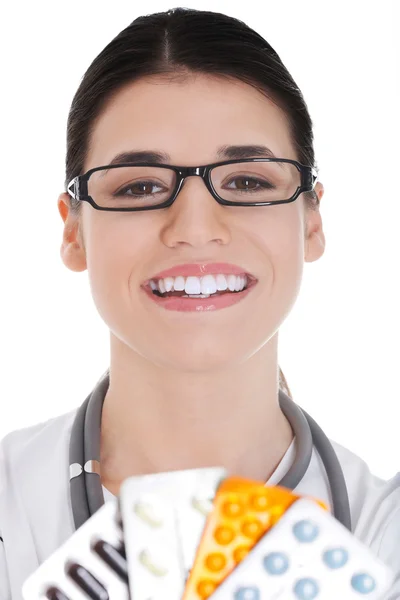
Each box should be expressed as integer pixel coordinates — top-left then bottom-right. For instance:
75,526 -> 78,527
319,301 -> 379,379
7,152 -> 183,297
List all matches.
59,75 -> 324,371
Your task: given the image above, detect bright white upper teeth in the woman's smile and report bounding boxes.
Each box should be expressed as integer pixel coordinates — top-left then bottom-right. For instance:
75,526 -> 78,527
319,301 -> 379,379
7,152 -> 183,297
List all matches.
149,274 -> 248,297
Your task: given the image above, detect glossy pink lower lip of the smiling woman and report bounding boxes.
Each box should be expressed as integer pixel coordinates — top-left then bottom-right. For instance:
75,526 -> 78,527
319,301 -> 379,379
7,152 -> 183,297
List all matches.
143,282 -> 256,312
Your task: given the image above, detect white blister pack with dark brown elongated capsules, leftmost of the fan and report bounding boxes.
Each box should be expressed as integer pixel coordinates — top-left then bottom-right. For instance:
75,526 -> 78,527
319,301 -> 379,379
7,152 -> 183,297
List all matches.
22,499 -> 129,600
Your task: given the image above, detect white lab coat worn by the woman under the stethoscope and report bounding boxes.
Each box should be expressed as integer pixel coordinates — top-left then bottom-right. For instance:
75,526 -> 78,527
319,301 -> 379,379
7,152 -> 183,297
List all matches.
0,409 -> 400,600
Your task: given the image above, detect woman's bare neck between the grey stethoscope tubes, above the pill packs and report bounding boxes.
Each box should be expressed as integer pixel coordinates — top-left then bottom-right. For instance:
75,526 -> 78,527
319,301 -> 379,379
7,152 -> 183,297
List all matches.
100,336 -> 293,493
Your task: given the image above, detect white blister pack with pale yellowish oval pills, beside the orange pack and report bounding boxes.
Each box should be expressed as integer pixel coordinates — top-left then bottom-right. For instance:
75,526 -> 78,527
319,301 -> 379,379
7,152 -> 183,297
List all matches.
119,467 -> 226,600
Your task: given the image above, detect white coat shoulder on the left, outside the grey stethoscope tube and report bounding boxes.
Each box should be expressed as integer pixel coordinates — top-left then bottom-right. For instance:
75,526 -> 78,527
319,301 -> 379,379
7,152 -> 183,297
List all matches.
0,409 -> 77,598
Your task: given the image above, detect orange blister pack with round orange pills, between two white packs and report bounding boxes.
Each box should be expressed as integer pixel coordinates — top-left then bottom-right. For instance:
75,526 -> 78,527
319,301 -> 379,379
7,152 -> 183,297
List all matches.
182,477 -> 327,600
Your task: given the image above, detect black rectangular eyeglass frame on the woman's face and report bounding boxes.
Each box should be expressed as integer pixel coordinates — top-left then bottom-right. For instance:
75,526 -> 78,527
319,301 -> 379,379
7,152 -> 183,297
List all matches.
67,158 -> 318,212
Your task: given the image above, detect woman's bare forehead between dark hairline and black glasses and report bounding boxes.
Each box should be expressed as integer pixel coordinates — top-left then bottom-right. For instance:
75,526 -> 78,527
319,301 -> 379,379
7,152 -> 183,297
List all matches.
84,75 -> 296,171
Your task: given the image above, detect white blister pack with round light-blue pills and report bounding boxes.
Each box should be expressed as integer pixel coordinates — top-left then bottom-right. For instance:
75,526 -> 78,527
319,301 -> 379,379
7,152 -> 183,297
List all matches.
210,498 -> 394,600
